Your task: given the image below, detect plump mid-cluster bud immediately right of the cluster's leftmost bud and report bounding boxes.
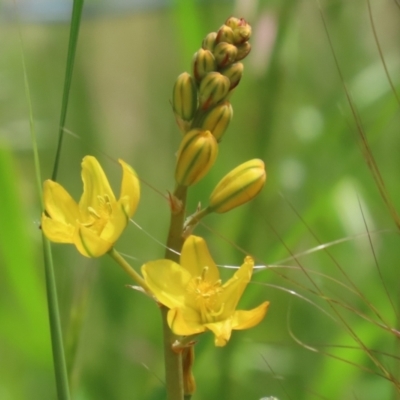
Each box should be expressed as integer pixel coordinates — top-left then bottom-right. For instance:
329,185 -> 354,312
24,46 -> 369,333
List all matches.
199,71 -> 231,110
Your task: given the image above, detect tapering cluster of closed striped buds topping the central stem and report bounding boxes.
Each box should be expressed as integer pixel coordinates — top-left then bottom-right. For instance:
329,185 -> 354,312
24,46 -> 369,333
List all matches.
172,17 -> 251,186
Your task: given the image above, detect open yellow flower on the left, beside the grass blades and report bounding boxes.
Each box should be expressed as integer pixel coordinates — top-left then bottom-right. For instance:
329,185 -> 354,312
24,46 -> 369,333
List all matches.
42,156 -> 140,257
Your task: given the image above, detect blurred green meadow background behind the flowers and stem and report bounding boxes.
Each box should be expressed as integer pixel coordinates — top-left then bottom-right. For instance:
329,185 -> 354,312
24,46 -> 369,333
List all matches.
0,0 -> 400,400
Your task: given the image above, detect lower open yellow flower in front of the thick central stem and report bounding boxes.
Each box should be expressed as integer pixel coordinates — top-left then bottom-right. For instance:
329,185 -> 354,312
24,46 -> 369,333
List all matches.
142,236 -> 269,346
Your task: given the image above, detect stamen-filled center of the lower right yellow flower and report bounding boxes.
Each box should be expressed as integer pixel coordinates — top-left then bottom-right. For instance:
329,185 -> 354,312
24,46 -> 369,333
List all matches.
187,266 -> 224,322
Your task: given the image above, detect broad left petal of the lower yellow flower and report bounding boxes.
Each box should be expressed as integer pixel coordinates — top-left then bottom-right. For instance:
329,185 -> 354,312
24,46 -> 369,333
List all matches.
142,260 -> 191,308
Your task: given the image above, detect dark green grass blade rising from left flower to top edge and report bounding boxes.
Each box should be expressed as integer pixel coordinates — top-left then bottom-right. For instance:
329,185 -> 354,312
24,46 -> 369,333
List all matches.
51,0 -> 84,181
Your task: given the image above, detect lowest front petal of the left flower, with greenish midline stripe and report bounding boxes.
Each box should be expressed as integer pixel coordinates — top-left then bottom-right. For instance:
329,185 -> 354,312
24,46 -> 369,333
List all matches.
73,225 -> 114,257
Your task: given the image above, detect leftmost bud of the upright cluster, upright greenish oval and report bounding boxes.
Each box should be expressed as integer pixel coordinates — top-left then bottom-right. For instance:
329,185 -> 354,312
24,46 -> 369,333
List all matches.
172,72 -> 197,121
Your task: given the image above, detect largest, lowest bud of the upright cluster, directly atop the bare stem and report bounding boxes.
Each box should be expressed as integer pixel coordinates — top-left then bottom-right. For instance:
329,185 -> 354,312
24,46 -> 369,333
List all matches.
175,129 -> 218,186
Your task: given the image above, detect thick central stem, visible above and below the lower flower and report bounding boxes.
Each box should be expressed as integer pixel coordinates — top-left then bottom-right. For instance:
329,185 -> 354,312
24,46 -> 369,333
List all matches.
161,186 -> 187,400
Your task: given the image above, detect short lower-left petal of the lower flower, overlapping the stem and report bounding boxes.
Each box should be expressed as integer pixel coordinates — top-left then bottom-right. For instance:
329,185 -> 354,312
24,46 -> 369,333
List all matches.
167,308 -> 205,336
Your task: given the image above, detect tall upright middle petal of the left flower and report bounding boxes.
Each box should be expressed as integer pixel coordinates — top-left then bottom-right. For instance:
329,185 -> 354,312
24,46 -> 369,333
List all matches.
79,156 -> 116,214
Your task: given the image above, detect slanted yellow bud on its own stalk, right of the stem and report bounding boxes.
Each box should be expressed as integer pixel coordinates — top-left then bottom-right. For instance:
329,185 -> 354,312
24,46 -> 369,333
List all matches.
207,159 -> 267,213
